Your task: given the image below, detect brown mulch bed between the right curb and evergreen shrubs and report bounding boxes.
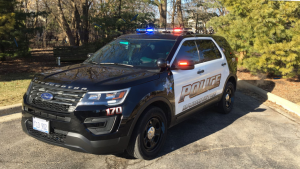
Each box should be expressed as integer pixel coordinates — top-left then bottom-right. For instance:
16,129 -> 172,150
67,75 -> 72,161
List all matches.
237,68 -> 300,105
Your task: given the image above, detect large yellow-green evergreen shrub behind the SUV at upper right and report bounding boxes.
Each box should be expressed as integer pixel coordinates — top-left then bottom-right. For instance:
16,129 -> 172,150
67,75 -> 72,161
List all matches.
209,0 -> 300,78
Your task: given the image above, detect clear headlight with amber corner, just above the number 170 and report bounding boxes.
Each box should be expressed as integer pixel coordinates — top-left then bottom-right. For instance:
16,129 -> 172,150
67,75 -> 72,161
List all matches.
78,88 -> 130,106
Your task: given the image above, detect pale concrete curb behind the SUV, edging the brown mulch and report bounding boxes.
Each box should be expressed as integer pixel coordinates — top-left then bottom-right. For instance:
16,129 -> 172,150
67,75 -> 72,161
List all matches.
237,79 -> 300,117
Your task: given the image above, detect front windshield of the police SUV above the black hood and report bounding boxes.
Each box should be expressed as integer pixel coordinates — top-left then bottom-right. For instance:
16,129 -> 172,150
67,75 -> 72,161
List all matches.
85,39 -> 175,68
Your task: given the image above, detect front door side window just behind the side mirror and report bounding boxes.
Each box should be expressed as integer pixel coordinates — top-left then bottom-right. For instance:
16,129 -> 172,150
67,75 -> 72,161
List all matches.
174,40 -> 199,64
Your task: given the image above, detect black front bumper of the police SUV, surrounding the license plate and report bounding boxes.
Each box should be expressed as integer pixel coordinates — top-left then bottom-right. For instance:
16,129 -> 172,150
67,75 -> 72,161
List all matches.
21,103 -> 130,154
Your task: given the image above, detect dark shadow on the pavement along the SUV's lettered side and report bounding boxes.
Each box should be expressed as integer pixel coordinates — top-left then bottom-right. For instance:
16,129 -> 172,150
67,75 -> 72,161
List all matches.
159,92 -> 266,156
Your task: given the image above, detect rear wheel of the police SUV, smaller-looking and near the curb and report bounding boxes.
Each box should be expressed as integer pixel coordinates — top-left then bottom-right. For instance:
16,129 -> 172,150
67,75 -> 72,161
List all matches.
218,82 -> 235,114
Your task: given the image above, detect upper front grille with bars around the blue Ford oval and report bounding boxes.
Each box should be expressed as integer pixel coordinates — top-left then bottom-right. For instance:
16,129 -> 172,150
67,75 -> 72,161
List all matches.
28,83 -> 85,113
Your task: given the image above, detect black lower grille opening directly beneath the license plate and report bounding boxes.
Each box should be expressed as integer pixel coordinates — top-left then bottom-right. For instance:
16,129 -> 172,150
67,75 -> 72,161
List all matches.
26,121 -> 67,144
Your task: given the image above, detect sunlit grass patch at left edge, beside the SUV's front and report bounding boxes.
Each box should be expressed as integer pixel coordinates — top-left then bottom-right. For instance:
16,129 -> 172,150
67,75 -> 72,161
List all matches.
0,73 -> 34,106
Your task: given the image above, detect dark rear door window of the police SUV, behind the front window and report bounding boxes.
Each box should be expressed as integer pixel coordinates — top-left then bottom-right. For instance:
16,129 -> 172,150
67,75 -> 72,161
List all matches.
196,40 -> 222,62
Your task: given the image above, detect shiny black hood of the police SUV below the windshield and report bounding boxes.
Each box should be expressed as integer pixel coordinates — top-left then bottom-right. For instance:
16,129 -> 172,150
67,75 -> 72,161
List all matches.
35,64 -> 159,91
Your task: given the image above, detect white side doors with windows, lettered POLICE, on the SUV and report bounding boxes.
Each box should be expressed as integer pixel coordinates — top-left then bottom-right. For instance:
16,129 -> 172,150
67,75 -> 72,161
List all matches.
171,37 -> 229,115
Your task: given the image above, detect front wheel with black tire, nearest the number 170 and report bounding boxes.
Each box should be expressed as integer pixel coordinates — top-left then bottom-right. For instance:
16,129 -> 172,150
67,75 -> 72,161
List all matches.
126,107 -> 167,160
